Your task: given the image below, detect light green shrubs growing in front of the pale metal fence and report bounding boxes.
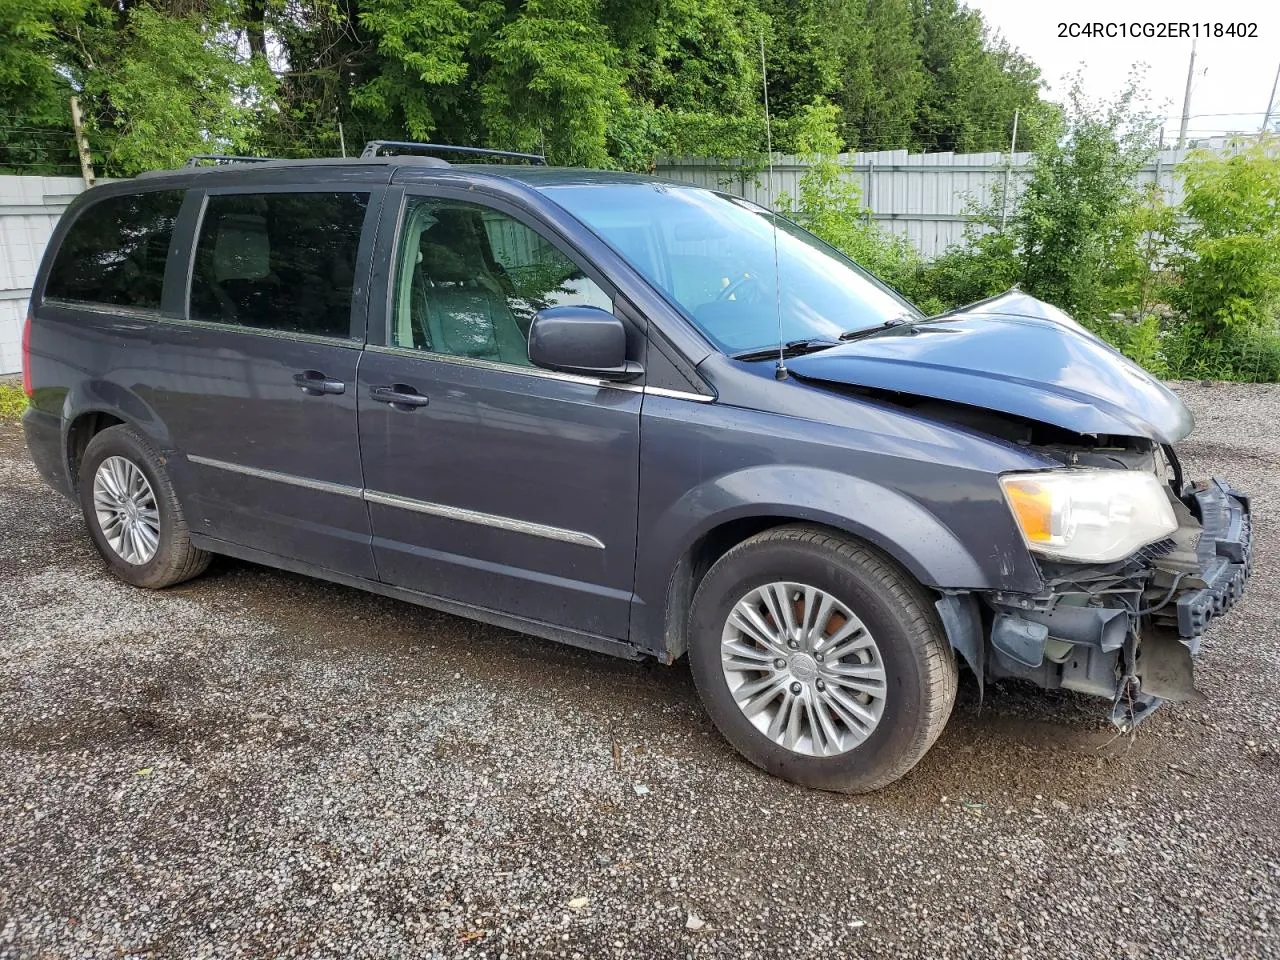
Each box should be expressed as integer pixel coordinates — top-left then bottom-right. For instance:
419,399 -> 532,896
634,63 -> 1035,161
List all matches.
782,82 -> 1280,381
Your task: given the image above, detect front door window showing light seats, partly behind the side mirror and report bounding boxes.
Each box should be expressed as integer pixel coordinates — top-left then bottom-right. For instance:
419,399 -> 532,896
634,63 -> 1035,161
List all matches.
392,197 -> 613,366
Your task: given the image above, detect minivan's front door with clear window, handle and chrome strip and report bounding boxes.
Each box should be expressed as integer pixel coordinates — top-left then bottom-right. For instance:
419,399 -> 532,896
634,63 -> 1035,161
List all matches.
358,193 -> 643,639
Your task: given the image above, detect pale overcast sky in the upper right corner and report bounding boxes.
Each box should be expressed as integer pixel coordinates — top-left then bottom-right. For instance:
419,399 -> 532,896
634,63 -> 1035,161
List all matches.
965,0 -> 1280,142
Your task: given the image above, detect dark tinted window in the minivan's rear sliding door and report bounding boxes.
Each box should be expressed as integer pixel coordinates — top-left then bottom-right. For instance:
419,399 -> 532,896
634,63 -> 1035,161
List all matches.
191,193 -> 369,338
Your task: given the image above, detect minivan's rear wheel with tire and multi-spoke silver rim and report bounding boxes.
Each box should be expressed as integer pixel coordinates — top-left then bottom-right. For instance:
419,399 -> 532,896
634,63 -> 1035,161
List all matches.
77,425 -> 211,590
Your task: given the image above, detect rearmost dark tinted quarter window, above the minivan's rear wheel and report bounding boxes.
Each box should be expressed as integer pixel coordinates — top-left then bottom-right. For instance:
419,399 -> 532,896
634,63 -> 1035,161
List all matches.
45,191 -> 182,310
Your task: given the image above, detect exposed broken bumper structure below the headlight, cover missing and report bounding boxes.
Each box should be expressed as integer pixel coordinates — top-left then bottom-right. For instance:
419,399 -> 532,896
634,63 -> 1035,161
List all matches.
967,479 -> 1253,731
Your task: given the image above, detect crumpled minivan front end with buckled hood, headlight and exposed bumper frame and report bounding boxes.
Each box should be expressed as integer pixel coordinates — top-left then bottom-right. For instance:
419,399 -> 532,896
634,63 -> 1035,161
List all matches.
787,289 -> 1251,730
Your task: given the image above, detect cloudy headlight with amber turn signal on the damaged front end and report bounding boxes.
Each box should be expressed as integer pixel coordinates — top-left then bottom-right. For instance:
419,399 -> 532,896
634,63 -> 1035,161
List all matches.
1000,470 -> 1178,563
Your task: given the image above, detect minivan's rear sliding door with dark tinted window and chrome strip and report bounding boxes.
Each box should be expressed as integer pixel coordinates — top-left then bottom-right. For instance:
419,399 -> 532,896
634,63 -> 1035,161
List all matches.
158,191 -> 378,580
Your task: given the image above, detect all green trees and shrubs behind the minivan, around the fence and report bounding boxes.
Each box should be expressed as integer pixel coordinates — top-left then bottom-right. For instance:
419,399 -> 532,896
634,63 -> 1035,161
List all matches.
0,0 -> 1280,380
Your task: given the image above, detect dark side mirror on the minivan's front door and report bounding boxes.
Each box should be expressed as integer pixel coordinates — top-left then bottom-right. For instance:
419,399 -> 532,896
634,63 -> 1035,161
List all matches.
529,307 -> 643,380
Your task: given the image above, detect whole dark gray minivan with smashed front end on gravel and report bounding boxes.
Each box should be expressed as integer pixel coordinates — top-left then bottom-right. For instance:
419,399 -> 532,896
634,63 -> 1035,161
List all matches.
23,143 -> 1251,791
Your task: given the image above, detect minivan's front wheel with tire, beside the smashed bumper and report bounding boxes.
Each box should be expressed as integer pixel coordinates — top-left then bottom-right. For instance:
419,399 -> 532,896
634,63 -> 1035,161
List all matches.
689,525 -> 957,794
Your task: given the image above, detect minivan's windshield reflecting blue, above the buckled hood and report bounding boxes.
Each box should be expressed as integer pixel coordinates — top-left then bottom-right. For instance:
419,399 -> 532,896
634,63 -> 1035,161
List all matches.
545,182 -> 919,353
